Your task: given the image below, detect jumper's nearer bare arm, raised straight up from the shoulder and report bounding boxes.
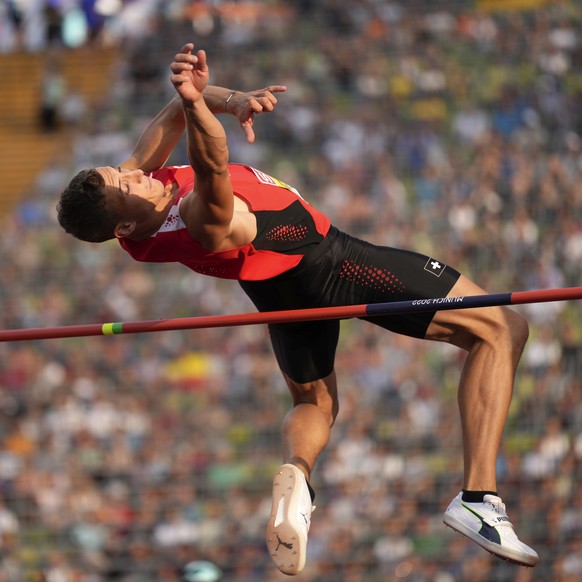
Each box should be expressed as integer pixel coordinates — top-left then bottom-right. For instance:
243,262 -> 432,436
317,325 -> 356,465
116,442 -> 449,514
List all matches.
170,43 -> 248,251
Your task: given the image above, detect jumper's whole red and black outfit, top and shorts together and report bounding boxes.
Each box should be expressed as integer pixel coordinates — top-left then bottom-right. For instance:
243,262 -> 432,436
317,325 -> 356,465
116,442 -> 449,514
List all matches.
120,164 -> 459,382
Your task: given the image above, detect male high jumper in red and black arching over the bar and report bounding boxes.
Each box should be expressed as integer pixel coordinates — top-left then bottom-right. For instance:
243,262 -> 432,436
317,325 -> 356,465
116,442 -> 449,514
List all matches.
58,44 -> 538,575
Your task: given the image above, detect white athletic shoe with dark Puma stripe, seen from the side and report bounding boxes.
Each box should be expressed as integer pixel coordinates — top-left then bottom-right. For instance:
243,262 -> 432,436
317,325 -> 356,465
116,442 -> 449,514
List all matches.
443,492 -> 539,567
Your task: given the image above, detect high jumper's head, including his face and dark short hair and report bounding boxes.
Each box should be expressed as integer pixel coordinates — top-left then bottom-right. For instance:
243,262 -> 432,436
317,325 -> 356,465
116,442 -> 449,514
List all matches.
57,166 -> 172,242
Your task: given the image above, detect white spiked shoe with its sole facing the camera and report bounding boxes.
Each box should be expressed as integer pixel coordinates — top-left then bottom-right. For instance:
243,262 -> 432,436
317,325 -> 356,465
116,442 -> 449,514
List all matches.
265,464 -> 315,576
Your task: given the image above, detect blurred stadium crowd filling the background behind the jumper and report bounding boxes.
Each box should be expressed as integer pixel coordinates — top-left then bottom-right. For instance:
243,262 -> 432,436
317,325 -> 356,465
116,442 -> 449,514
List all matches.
0,0 -> 582,582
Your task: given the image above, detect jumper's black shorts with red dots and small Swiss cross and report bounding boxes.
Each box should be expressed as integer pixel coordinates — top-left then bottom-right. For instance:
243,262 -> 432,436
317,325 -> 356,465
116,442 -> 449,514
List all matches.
240,227 -> 460,383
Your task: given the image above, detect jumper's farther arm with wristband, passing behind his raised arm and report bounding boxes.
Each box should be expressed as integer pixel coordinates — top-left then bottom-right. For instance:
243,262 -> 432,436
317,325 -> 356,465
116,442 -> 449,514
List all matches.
120,85 -> 287,172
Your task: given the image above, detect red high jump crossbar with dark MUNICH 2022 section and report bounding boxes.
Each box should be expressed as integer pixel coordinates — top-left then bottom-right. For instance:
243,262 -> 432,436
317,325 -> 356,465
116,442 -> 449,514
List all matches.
0,287 -> 582,342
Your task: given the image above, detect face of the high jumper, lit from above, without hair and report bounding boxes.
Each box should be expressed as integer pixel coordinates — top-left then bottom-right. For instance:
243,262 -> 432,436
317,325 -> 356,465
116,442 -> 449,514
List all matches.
97,166 -> 173,236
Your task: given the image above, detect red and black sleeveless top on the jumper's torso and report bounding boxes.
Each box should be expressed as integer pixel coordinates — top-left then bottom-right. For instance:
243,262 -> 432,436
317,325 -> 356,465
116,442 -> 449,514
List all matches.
119,164 -> 330,281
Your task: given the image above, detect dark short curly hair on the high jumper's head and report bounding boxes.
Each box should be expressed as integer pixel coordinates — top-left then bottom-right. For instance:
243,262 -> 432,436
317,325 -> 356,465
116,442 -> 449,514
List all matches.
57,168 -> 118,242
